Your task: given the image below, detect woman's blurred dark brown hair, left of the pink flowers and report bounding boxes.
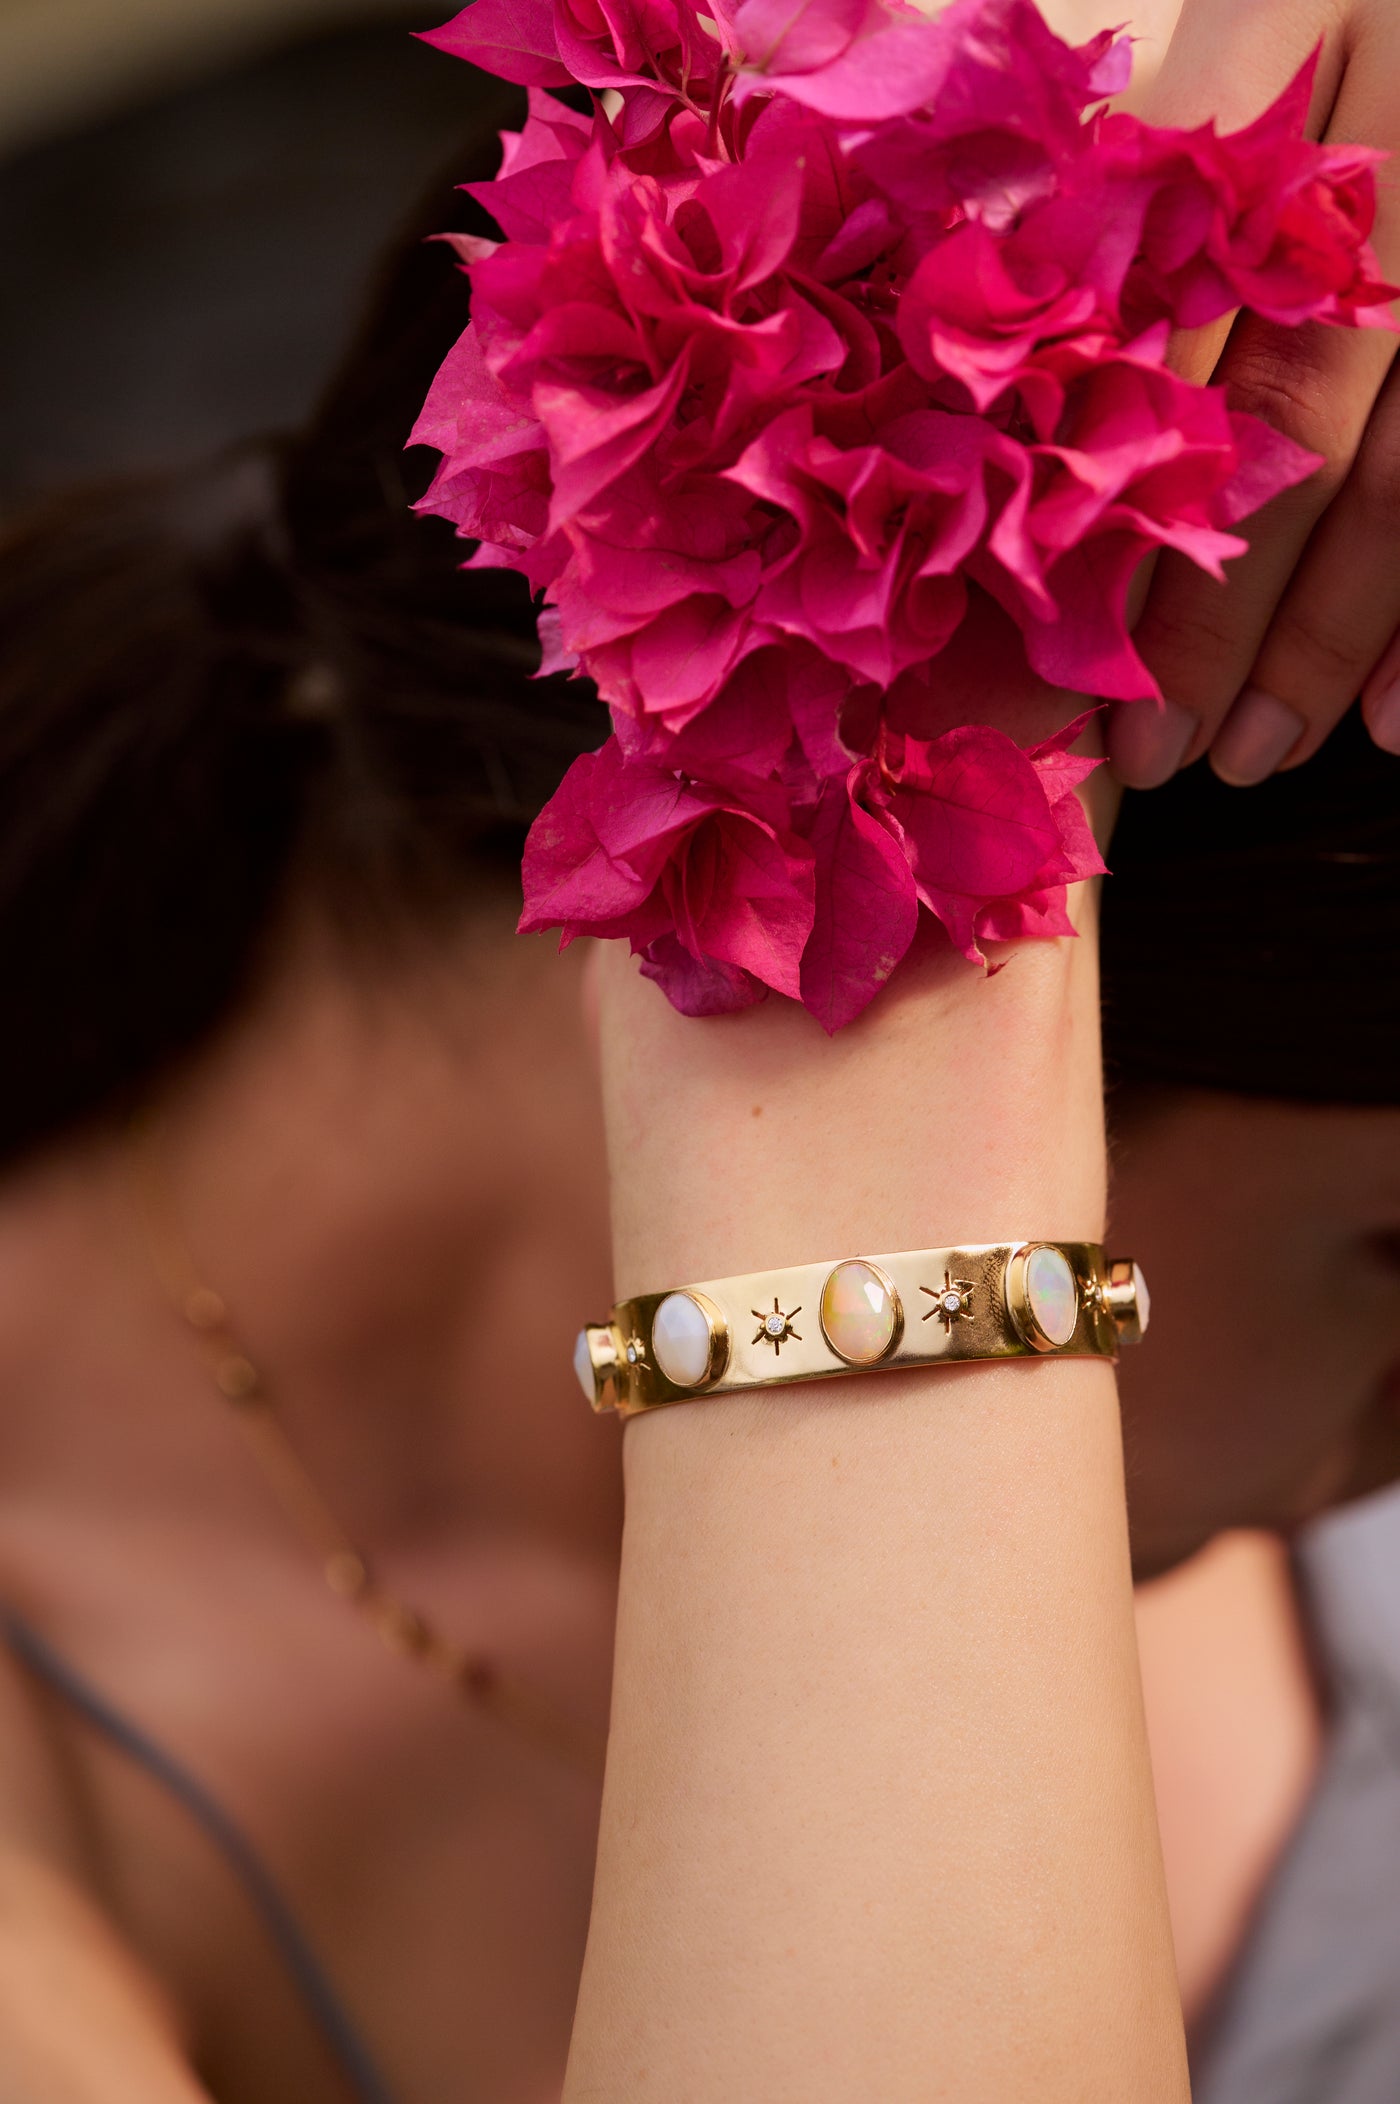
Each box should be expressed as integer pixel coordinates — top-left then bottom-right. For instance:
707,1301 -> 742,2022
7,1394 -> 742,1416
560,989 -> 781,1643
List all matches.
0,102 -> 593,1161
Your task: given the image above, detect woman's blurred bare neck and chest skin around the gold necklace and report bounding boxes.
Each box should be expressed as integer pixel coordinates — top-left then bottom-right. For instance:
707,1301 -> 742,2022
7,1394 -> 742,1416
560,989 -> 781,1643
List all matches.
0,909 -> 619,2104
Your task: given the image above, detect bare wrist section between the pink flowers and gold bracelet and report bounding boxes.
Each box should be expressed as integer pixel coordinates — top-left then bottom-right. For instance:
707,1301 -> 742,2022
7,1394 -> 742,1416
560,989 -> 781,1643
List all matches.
598,892 -> 1105,1298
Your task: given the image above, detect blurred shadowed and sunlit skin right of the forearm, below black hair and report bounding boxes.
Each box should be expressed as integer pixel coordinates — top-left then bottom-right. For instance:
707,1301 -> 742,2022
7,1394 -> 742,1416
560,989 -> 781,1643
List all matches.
1112,1092 -> 1400,2020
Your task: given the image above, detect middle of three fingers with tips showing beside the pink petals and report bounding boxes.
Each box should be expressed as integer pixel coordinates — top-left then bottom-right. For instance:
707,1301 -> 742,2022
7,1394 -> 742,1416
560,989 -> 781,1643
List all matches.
1211,8 -> 1400,783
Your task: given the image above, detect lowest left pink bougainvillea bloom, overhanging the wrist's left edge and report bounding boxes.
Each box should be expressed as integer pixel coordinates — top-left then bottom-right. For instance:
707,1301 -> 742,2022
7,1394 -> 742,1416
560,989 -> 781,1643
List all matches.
520,739 -> 815,1012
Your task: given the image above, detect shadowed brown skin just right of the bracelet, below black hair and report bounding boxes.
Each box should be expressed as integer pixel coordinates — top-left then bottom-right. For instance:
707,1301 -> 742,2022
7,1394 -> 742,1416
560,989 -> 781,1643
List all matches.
1114,1092 -> 1400,1574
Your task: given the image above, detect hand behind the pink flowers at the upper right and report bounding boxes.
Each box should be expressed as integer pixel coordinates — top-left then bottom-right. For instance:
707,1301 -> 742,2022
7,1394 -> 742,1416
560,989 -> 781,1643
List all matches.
1109,0 -> 1400,789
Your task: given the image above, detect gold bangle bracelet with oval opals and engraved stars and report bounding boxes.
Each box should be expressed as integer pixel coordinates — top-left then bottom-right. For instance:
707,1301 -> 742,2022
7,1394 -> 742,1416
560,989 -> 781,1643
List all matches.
575,1241 -> 1149,1418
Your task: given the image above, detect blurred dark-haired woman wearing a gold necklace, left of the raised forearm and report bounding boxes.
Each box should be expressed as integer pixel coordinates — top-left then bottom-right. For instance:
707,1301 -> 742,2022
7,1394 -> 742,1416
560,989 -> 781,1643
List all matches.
0,131 -> 619,2104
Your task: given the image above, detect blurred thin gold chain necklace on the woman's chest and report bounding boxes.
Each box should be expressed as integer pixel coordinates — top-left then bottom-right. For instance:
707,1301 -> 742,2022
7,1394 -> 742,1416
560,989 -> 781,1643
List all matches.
133,1145 -> 606,1780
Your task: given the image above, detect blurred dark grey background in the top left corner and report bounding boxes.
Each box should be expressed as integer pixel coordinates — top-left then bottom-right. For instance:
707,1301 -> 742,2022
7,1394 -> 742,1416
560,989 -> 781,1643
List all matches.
0,0 -> 472,509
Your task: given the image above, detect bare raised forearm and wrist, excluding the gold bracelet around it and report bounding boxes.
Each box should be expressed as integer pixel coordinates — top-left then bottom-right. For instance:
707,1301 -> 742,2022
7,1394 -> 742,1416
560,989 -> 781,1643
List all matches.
566,913 -> 1185,2104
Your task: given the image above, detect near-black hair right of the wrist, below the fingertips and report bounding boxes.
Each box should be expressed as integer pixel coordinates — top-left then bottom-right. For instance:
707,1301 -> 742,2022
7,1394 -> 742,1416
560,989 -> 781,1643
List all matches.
1103,709 -> 1400,1105
